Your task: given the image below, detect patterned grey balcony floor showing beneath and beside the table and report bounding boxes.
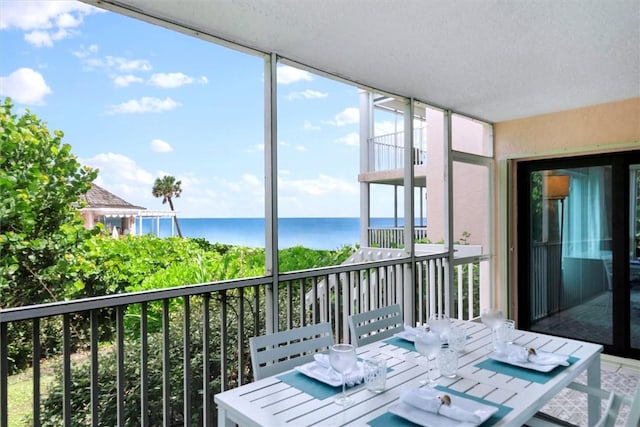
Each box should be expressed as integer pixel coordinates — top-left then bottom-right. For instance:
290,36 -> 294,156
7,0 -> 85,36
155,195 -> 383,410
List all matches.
542,355 -> 640,426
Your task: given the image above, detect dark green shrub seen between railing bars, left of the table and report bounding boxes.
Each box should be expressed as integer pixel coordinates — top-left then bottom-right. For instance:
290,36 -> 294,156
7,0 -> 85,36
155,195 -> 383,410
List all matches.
41,306 -> 220,427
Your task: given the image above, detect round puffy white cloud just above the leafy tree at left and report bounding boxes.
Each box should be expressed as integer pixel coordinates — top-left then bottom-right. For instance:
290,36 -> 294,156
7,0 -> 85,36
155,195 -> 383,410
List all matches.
0,68 -> 51,105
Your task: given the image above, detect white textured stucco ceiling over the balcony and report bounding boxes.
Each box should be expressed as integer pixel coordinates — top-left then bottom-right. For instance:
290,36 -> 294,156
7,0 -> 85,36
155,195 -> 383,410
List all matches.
85,0 -> 640,122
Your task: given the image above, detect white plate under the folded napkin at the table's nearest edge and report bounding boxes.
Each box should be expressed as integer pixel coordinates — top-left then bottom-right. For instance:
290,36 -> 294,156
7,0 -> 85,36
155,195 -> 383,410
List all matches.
389,396 -> 498,427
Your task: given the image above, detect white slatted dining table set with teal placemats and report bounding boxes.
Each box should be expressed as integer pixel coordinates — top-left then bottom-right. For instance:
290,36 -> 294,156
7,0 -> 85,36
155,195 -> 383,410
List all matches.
214,321 -> 602,427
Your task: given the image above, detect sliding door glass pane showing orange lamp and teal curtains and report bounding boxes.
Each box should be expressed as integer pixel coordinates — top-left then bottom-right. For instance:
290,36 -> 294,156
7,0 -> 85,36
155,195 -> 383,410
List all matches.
530,166 -> 613,344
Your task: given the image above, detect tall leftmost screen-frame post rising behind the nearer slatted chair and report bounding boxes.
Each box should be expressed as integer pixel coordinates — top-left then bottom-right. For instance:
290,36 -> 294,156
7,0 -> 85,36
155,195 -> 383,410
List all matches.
264,53 -> 279,333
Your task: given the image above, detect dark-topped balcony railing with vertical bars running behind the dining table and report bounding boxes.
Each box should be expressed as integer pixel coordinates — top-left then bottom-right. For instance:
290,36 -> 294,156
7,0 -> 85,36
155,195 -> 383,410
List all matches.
0,253 -> 480,427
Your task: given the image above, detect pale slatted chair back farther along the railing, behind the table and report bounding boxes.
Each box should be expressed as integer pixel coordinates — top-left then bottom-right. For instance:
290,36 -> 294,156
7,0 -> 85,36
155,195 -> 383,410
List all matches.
349,304 -> 404,347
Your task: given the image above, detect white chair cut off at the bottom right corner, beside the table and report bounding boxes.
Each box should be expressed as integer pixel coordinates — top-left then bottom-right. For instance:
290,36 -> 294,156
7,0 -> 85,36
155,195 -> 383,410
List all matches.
527,382 -> 640,427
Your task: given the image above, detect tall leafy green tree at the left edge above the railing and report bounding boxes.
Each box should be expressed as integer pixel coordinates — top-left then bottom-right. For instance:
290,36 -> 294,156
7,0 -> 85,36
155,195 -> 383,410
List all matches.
0,98 -> 97,308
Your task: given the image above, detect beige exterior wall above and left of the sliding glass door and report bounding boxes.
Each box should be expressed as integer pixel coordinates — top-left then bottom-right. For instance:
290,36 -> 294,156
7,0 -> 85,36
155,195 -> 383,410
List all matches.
494,98 -> 640,317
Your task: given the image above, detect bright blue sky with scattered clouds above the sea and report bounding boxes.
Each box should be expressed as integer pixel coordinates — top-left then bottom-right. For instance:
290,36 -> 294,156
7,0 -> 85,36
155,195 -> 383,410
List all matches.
0,0 -> 392,218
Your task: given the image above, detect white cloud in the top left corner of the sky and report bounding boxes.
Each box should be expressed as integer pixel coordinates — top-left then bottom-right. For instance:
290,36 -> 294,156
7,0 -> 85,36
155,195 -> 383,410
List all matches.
0,1 -> 106,47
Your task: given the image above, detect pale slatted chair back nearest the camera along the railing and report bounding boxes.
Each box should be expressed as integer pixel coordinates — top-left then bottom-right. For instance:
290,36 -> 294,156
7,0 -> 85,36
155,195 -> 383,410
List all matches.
249,322 -> 333,380
